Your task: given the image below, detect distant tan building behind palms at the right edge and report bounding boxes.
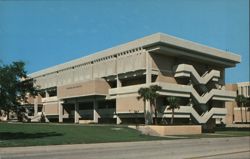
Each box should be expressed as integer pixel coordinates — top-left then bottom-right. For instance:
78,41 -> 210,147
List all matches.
225,82 -> 250,125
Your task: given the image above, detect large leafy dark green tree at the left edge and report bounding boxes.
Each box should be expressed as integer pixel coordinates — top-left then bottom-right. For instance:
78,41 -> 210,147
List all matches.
0,61 -> 37,119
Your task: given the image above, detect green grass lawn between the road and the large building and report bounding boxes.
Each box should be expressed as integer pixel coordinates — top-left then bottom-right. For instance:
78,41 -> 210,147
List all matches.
0,123 -> 250,147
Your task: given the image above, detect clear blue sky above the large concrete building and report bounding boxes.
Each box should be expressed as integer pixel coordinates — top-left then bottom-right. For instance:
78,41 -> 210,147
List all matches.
0,0 -> 249,83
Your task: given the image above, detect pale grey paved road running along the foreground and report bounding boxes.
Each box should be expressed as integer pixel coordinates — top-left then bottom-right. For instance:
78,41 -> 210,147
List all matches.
0,137 -> 250,159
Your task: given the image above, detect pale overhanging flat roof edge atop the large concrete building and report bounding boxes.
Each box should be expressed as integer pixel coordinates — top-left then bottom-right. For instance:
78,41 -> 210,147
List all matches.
28,33 -> 241,78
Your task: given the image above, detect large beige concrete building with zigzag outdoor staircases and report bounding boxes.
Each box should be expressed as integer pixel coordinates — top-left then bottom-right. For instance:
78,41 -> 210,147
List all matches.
26,33 -> 240,124
